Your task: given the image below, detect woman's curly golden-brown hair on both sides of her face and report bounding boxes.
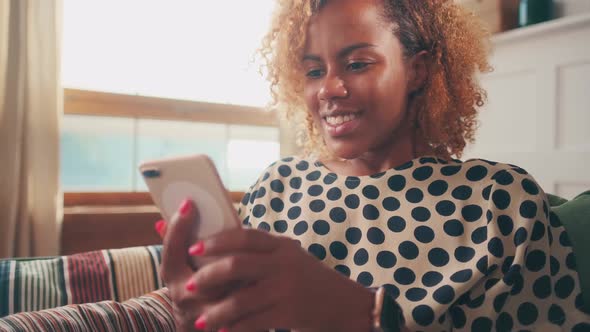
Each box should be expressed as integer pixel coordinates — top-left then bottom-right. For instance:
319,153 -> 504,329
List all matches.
259,0 -> 492,159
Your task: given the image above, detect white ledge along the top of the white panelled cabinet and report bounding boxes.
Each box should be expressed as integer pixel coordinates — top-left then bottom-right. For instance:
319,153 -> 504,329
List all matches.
492,13 -> 590,44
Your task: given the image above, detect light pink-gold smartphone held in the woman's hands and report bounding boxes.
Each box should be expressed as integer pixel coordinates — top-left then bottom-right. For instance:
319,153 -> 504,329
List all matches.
139,154 -> 241,255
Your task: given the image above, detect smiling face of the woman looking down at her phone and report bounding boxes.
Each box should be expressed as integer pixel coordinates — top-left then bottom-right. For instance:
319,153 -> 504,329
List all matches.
303,0 -> 416,159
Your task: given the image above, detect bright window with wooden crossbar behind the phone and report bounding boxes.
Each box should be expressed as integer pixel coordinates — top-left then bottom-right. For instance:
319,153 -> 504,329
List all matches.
61,0 -> 280,192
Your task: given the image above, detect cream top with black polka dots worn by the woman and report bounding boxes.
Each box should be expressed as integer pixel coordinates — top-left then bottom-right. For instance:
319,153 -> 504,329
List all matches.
239,157 -> 590,331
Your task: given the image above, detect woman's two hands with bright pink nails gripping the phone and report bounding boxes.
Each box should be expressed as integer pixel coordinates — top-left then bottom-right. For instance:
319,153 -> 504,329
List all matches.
157,200 -> 373,332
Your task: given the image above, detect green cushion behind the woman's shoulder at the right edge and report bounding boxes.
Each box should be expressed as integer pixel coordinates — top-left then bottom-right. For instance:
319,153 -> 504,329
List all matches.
548,190 -> 590,313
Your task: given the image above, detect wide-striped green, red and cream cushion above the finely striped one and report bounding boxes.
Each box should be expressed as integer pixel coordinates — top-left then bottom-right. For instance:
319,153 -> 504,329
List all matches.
0,246 -> 163,317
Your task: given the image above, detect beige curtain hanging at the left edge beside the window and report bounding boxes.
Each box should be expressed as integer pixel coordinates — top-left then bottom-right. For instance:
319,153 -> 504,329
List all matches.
0,0 -> 63,258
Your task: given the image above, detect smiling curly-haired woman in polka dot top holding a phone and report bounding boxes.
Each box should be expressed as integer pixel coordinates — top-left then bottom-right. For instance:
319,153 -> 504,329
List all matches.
159,0 -> 590,331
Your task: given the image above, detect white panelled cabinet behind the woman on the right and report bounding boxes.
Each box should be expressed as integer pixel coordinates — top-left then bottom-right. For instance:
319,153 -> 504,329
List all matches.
464,14 -> 590,198
